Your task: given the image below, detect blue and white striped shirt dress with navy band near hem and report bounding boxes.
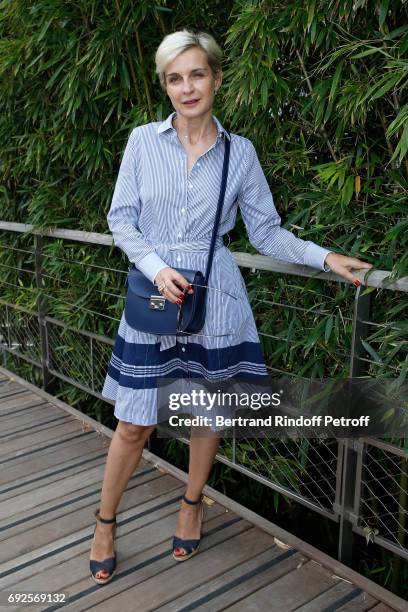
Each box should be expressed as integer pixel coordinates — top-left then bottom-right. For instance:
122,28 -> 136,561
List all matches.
101,112 -> 330,425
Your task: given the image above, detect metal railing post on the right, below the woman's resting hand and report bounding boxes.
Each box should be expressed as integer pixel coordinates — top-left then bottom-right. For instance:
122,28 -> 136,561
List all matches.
338,286 -> 370,566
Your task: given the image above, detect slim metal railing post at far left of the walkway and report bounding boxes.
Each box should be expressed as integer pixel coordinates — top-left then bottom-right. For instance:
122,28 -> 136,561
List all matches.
34,234 -> 56,394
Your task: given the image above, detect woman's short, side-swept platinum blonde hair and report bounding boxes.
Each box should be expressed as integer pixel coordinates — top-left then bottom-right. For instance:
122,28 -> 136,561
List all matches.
155,29 -> 222,89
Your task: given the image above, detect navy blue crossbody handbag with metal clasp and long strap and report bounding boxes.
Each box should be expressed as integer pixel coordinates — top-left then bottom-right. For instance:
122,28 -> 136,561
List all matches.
124,131 -> 230,335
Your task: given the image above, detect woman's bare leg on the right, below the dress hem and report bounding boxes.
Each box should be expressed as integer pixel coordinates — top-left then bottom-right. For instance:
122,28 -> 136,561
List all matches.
175,427 -> 220,555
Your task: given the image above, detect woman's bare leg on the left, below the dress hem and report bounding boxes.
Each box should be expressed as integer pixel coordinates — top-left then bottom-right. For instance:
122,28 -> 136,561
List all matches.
90,421 -> 155,578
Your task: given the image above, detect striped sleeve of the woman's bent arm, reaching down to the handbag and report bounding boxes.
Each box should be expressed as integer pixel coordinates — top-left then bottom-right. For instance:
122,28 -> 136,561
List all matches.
107,128 -> 168,282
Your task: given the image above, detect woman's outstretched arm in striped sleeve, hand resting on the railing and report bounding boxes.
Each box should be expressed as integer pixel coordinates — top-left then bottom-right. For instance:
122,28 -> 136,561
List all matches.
238,141 -> 372,283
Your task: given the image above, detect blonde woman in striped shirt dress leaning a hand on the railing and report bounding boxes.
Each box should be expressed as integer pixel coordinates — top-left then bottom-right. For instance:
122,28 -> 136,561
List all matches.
91,30 -> 371,584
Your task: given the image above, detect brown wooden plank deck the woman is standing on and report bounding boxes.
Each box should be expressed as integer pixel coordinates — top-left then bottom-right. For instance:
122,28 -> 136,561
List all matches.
0,368 -> 407,612
